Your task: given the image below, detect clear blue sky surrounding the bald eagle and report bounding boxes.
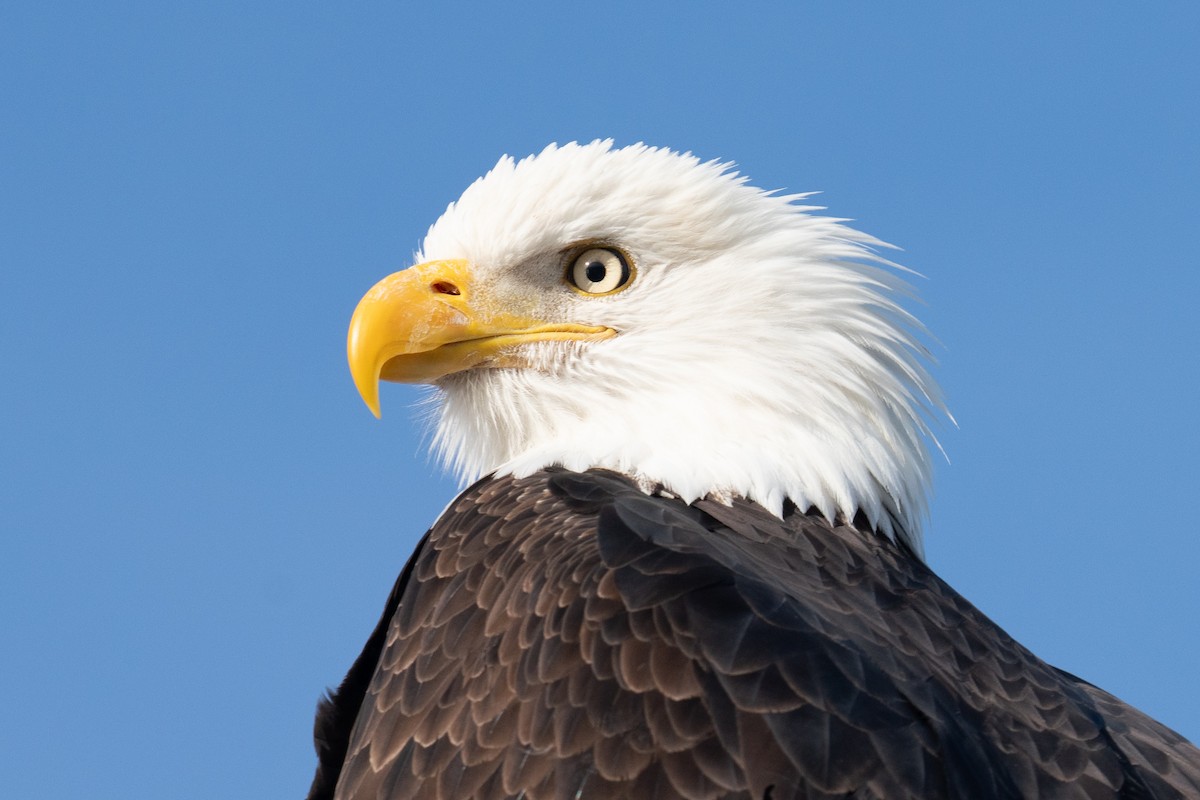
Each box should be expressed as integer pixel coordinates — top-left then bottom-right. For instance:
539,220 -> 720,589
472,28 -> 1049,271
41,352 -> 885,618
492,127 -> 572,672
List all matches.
0,0 -> 1200,800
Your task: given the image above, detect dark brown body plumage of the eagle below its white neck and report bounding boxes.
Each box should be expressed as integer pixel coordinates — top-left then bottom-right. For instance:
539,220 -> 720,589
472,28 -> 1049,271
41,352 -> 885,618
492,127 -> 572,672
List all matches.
310,470 -> 1200,800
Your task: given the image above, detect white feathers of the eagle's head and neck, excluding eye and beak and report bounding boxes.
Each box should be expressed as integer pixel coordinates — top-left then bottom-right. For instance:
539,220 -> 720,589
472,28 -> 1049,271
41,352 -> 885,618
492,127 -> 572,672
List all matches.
419,142 -> 944,554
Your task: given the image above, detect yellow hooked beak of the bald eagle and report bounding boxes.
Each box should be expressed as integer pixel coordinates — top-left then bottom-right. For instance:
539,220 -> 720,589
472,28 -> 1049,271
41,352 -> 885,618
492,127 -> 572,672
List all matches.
346,261 -> 616,416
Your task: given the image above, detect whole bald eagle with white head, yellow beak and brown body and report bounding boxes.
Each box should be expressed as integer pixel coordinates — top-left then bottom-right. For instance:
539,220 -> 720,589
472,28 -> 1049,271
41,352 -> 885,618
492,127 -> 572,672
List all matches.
308,142 -> 1200,800
